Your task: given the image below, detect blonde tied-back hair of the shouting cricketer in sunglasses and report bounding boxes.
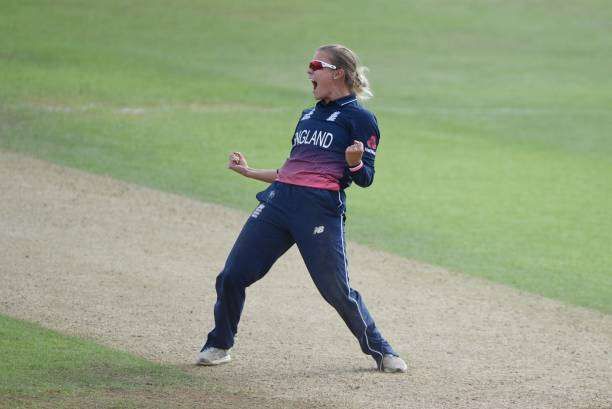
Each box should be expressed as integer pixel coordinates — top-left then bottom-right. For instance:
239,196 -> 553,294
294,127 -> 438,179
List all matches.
317,44 -> 374,99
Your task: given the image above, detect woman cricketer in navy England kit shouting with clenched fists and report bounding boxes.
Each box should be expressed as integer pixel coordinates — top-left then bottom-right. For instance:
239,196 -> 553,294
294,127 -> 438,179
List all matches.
197,45 -> 407,372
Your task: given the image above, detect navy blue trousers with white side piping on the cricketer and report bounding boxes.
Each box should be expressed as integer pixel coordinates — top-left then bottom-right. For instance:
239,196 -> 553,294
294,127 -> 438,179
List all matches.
202,182 -> 397,367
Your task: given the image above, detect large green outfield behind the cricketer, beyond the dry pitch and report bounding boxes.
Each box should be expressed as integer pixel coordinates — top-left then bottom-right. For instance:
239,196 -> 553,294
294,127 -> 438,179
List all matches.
0,0 -> 612,313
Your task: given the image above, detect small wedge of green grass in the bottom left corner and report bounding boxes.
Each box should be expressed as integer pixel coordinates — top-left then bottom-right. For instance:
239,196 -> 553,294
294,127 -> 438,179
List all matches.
0,315 -> 193,408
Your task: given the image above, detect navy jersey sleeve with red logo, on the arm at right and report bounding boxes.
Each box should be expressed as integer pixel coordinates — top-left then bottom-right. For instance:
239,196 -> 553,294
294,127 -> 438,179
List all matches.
344,112 -> 380,187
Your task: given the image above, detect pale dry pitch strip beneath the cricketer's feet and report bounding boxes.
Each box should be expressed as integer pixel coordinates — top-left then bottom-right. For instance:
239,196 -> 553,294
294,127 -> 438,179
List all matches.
0,152 -> 612,409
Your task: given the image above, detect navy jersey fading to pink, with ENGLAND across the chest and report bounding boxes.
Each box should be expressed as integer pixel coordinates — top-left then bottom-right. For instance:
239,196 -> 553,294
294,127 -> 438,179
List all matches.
276,94 -> 380,191
